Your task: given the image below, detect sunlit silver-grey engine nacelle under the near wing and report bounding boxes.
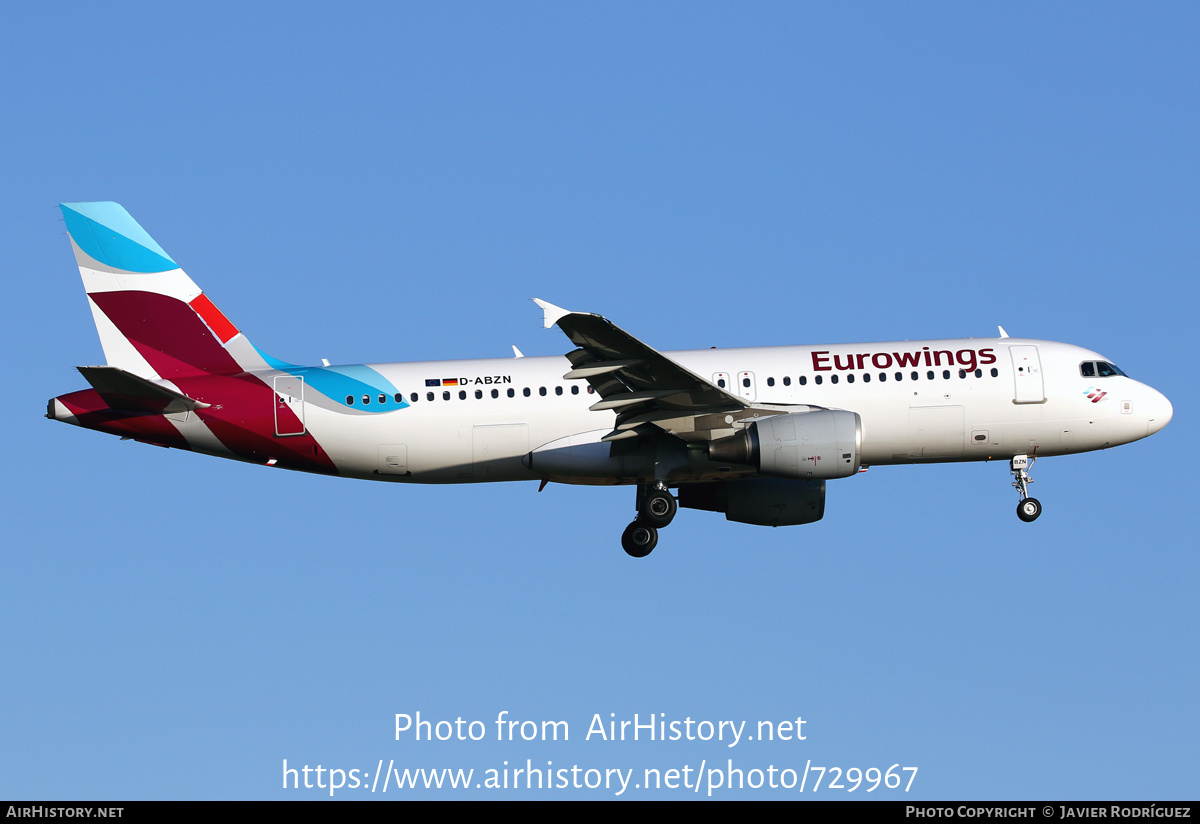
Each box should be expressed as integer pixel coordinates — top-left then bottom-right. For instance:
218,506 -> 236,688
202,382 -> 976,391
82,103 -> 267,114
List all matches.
708,409 -> 863,481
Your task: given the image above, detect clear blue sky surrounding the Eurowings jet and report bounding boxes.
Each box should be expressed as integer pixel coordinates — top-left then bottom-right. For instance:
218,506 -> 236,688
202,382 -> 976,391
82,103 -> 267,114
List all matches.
0,2 -> 1200,799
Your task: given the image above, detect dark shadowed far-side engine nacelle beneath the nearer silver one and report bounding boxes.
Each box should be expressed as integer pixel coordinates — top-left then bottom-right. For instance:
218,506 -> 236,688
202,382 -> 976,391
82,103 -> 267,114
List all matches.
678,477 -> 824,527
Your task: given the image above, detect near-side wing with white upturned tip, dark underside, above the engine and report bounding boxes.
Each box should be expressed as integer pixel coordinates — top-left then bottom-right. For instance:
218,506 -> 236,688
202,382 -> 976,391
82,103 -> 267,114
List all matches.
534,297 -> 778,443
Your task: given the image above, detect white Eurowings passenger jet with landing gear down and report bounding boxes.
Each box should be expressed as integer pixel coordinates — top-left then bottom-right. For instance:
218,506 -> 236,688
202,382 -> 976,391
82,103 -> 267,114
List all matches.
47,203 -> 1172,558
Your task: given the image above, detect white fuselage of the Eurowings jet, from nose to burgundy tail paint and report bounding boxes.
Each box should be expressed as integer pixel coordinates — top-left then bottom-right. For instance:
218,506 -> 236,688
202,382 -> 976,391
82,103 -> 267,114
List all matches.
270,338 -> 1171,483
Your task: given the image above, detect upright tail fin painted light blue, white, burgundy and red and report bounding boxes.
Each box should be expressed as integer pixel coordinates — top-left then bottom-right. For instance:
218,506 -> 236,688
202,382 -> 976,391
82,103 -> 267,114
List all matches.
61,203 -> 270,380
